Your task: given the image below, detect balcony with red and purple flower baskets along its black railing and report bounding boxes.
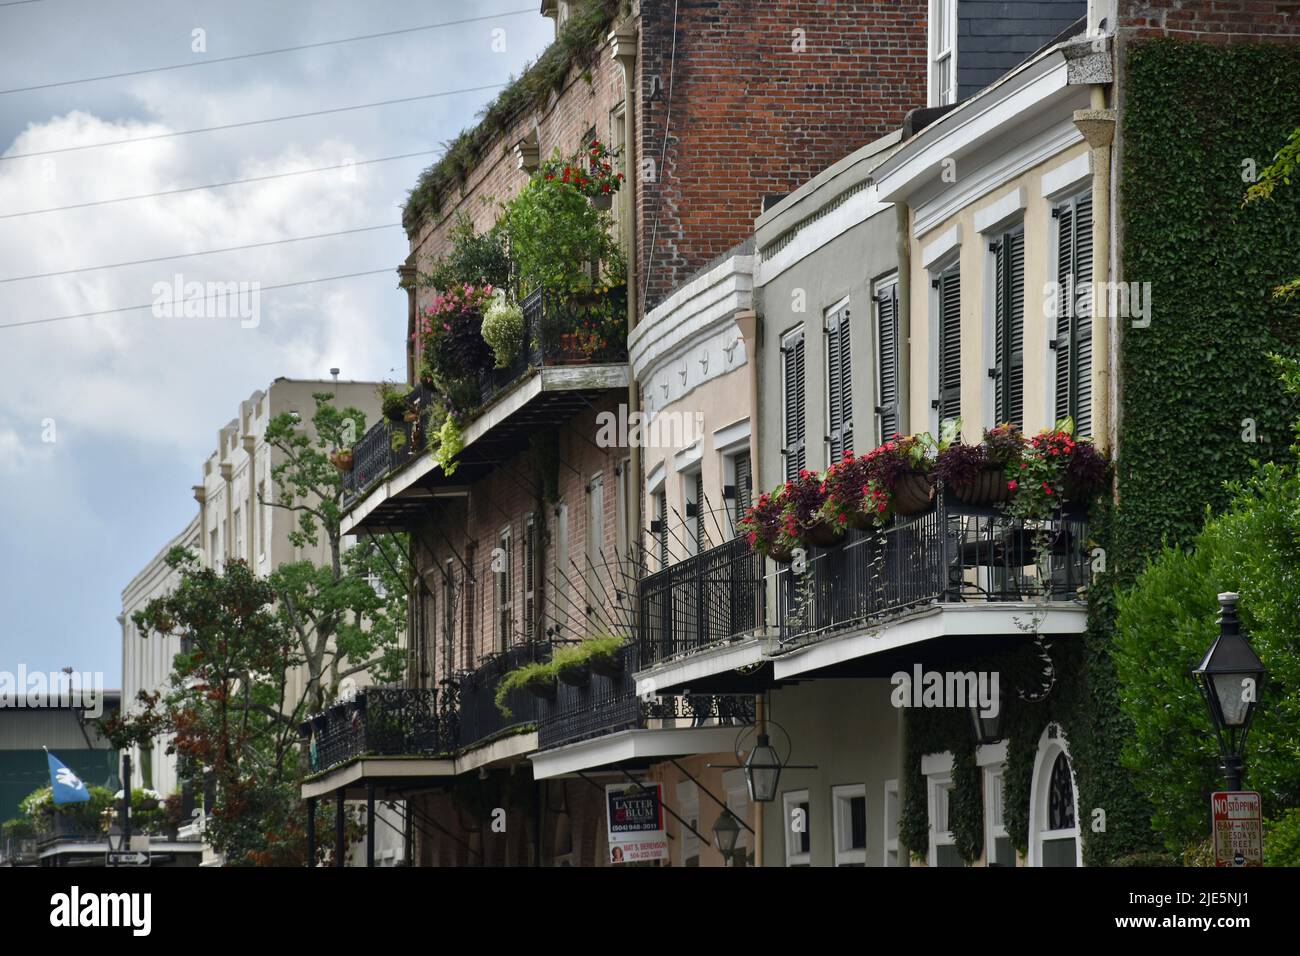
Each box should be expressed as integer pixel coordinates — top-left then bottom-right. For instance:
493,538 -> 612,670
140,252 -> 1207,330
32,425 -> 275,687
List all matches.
639,420 -> 1110,680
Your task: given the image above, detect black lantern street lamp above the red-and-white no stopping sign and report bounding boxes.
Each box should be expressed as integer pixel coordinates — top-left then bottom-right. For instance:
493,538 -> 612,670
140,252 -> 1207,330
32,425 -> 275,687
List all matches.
1192,592 -> 1266,791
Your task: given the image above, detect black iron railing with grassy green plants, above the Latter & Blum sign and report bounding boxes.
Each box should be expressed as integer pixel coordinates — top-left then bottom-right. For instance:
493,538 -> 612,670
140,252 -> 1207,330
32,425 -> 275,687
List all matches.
537,644 -> 754,750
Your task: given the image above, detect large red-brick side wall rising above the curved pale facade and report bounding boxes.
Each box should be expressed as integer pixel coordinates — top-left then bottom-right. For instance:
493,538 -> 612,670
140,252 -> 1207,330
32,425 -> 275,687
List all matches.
637,0 -> 927,311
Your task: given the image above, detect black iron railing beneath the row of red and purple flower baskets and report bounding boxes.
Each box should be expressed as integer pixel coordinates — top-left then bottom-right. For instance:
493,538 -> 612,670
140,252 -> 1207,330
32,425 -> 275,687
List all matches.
777,494 -> 1091,644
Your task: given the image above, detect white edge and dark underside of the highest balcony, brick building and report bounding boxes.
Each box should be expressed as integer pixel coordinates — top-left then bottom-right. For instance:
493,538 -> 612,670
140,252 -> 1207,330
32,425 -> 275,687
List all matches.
343,364 -> 629,535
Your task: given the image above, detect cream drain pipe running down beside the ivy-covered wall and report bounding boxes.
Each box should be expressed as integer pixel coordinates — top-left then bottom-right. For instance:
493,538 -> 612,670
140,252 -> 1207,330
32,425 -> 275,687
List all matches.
1074,83 -> 1118,450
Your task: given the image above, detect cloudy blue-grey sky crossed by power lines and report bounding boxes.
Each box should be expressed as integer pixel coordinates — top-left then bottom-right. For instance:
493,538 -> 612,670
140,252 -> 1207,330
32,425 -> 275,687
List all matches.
0,0 -> 553,688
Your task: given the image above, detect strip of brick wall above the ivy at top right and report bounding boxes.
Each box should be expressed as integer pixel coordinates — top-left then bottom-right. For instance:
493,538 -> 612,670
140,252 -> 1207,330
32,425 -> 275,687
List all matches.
1119,0 -> 1300,43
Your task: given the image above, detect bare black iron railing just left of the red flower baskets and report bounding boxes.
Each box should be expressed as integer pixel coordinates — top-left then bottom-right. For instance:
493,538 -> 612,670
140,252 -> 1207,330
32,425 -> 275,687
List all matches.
638,537 -> 767,666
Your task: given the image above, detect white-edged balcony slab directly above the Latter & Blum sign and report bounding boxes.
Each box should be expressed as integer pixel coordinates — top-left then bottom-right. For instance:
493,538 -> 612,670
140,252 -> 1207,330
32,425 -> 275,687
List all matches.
532,726 -> 742,780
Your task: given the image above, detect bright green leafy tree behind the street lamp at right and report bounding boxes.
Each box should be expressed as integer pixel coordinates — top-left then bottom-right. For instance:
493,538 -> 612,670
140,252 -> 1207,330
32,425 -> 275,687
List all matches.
1114,358 -> 1300,851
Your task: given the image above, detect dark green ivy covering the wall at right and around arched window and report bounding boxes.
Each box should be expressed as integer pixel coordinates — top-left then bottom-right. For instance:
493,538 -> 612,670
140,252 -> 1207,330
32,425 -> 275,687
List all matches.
901,39 -> 1300,866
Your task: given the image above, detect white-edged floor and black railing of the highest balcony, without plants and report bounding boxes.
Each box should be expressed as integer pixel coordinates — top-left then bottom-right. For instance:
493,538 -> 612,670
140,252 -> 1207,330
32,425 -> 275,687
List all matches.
343,286 -> 631,533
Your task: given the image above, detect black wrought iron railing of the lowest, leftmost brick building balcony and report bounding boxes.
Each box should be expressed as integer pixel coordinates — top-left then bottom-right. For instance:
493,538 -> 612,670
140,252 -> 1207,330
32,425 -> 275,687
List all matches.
303,687 -> 455,773
